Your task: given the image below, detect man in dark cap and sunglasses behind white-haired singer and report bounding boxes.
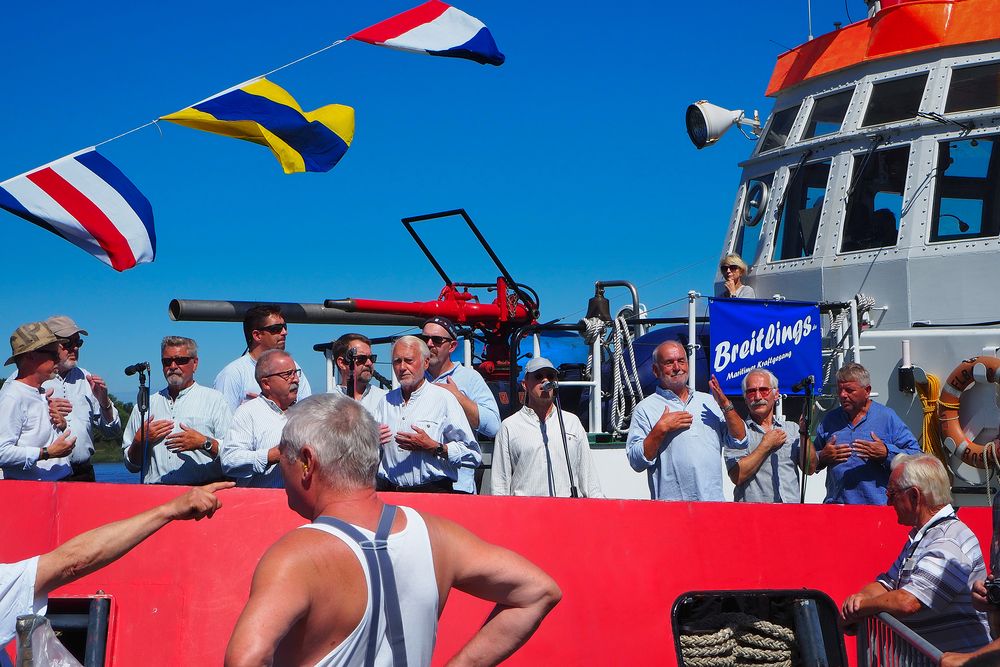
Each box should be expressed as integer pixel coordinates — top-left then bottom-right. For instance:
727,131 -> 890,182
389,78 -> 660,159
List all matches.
419,317 -> 500,493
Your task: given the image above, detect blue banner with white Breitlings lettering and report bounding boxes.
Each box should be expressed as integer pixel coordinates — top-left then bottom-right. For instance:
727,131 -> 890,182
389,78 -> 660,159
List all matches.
708,299 -> 823,394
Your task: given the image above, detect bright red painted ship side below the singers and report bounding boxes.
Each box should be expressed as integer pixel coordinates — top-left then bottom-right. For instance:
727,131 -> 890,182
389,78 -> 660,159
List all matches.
0,481 -> 991,667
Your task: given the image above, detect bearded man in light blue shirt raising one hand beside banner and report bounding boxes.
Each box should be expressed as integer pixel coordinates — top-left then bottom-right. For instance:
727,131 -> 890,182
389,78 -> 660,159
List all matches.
626,340 -> 747,502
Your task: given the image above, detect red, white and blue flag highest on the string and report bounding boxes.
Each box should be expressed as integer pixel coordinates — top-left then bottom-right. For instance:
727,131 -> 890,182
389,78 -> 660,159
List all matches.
348,0 -> 505,65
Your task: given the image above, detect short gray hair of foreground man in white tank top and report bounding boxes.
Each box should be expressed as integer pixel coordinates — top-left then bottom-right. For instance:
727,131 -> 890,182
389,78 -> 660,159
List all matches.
279,394 -> 380,490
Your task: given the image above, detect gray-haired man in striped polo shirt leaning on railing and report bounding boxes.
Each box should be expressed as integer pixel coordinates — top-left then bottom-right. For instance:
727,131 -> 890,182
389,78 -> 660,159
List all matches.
841,454 -> 990,653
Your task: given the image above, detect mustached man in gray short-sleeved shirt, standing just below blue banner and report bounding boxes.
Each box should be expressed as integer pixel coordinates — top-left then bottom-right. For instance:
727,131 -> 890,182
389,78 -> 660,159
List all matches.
726,368 -> 812,503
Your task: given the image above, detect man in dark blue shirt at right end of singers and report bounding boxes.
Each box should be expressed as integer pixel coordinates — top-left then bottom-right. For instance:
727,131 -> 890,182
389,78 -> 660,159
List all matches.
814,363 -> 921,505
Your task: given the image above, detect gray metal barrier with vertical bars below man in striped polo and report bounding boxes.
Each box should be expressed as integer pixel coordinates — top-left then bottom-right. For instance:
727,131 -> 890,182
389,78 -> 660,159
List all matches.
858,612 -> 941,667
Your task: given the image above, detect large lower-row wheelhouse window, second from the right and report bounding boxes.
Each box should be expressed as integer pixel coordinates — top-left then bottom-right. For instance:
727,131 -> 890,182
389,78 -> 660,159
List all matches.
840,146 -> 910,252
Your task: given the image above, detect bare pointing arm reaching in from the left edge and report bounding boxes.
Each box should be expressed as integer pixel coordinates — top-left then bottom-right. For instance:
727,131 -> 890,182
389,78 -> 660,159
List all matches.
35,482 -> 233,595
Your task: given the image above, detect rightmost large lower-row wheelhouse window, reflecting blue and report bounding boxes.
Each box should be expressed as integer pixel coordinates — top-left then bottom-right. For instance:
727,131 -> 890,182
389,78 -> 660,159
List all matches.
930,137 -> 1000,242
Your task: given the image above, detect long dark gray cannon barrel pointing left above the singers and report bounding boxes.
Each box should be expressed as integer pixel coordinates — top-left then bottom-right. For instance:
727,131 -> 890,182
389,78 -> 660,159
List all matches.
169,299 -> 426,327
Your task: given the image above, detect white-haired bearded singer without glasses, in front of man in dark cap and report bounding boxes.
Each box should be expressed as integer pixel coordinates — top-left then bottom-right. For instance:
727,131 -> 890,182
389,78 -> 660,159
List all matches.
373,336 -> 483,493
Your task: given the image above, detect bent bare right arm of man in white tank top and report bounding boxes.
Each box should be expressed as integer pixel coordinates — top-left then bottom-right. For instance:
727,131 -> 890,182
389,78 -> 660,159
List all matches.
424,516 -> 562,667
